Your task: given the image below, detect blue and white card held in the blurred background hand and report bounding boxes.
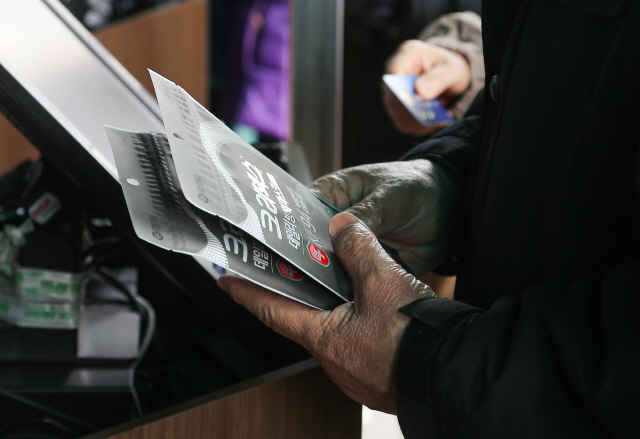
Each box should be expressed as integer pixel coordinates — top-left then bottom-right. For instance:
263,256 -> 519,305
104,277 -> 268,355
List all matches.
382,74 -> 453,126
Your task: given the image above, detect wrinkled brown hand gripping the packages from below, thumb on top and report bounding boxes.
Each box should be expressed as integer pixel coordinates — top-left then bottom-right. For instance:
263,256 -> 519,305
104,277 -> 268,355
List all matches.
218,213 -> 433,414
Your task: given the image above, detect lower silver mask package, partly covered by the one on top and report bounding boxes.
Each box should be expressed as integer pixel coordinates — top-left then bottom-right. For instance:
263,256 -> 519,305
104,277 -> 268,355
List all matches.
105,127 -> 344,310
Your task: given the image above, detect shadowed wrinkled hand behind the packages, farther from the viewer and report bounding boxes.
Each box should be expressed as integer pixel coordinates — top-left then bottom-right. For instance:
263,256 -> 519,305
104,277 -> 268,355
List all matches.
309,160 -> 457,277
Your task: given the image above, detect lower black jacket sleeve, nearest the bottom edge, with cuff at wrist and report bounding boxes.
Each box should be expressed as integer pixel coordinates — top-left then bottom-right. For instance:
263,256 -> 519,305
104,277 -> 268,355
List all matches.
397,195 -> 640,439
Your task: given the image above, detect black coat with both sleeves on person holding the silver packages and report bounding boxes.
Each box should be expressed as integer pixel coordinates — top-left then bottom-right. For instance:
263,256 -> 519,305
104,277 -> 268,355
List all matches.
398,0 -> 640,439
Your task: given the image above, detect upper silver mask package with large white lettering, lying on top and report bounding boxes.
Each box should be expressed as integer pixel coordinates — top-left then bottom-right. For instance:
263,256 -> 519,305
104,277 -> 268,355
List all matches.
151,72 -> 352,301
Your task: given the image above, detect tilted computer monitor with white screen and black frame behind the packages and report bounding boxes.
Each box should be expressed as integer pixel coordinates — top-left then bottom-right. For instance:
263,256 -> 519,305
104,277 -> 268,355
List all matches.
0,0 -> 225,308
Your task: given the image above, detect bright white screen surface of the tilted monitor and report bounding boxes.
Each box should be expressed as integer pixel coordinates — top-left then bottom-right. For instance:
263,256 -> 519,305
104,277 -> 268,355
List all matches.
0,0 -> 164,177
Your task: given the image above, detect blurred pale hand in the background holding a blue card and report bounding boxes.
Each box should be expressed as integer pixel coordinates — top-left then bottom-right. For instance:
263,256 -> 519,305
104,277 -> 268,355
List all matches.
383,40 -> 471,136
